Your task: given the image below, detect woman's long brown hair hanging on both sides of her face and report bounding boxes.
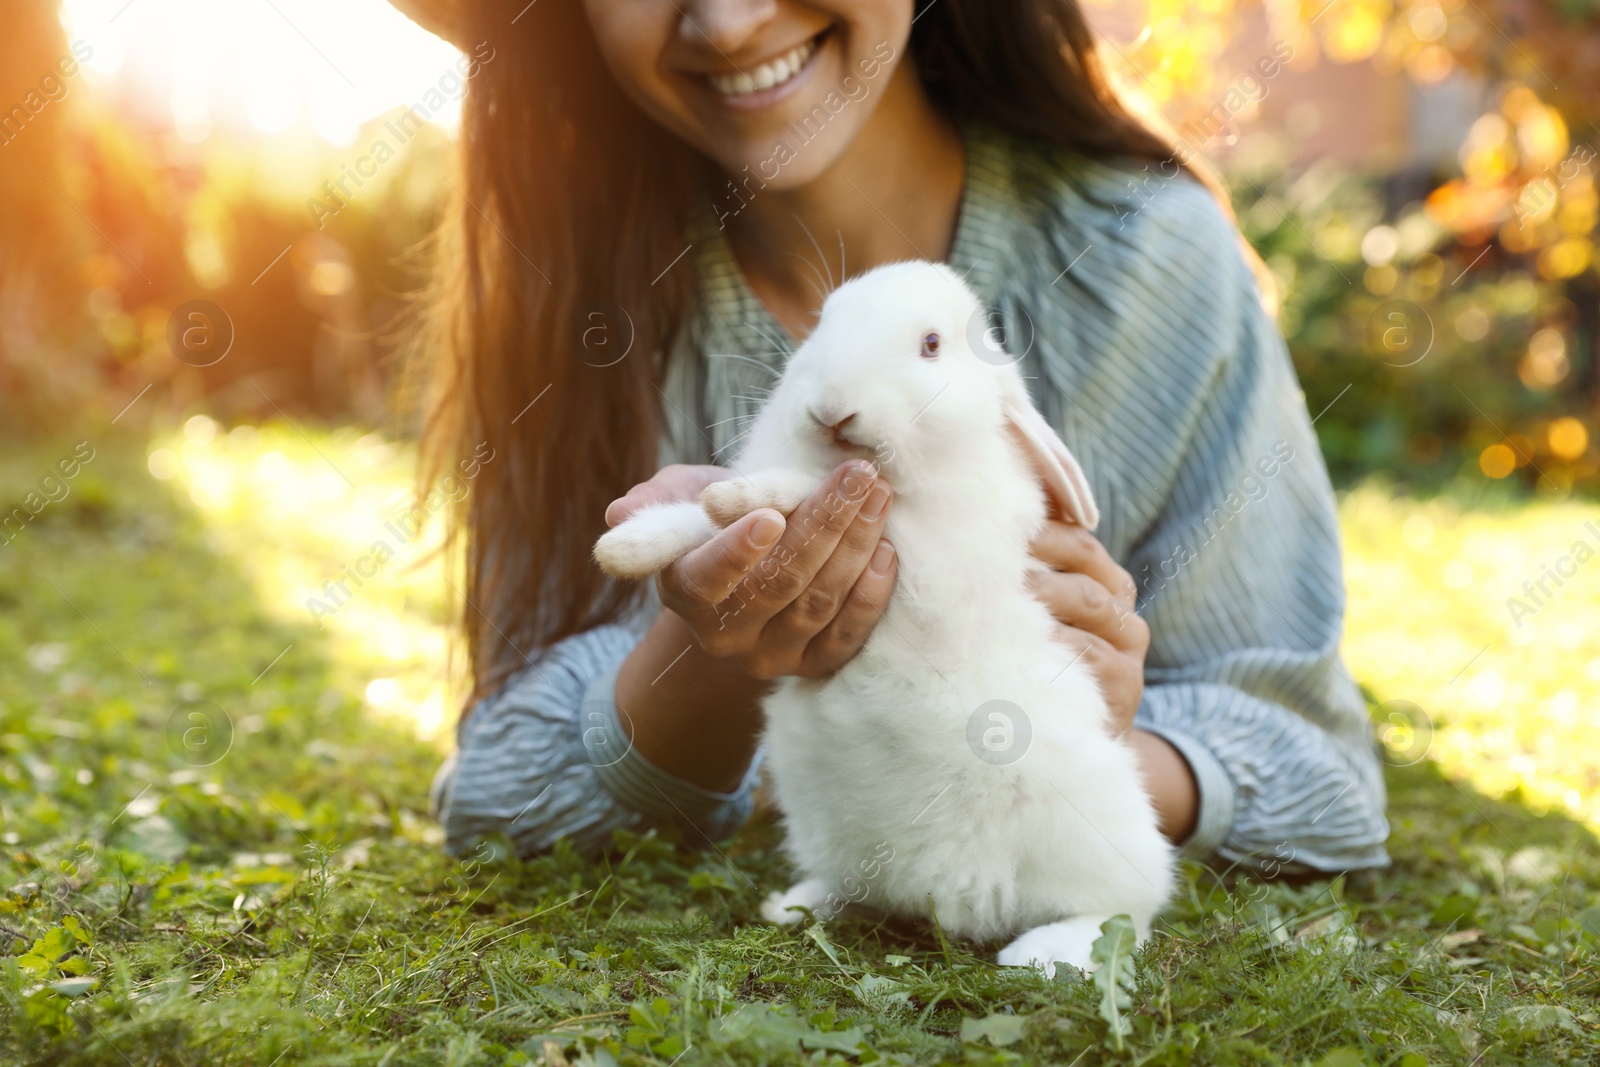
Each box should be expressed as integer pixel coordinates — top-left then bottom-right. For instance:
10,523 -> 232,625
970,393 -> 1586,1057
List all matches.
418,0 -> 1254,710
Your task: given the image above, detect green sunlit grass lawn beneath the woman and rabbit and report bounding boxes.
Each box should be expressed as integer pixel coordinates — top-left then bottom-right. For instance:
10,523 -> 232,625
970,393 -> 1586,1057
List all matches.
0,421 -> 1600,1067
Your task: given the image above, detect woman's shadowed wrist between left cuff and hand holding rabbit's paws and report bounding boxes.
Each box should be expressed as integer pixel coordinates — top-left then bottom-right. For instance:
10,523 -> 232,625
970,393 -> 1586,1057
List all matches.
614,609 -> 766,792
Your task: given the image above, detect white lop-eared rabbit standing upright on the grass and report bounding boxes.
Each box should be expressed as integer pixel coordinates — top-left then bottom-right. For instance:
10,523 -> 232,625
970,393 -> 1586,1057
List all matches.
595,262 -> 1174,974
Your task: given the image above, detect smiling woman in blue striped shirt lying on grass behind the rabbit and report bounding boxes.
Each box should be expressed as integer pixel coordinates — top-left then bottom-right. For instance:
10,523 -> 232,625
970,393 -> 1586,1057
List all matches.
402,0 -> 1387,870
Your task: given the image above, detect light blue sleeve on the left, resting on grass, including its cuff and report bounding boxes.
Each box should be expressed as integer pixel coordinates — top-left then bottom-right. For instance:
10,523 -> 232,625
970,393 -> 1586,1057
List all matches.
432,624 -> 758,856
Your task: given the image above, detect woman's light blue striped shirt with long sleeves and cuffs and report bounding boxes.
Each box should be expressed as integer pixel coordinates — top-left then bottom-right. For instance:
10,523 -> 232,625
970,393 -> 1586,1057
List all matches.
434,126 -> 1389,870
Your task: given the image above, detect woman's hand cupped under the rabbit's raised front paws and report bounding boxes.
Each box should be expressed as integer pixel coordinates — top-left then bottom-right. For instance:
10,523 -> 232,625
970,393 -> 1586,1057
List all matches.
606,461 -> 896,680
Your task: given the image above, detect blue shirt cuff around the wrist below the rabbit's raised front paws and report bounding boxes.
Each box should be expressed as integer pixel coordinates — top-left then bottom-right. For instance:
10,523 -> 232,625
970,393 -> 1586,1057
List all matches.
579,662 -> 762,845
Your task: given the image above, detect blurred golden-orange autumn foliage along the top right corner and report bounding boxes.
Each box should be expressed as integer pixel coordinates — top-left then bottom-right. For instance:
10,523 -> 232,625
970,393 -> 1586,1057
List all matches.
1110,0 -> 1600,271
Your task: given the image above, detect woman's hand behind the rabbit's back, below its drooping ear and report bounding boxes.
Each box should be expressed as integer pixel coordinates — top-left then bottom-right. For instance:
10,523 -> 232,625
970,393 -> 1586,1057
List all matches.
1029,518 -> 1150,736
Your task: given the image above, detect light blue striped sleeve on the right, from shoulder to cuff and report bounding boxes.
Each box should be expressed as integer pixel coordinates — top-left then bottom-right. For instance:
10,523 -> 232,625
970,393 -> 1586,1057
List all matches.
1125,199 -> 1389,870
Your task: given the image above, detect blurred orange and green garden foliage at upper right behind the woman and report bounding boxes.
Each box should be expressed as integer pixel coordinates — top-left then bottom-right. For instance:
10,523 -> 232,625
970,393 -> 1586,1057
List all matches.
1107,0 -> 1600,494
